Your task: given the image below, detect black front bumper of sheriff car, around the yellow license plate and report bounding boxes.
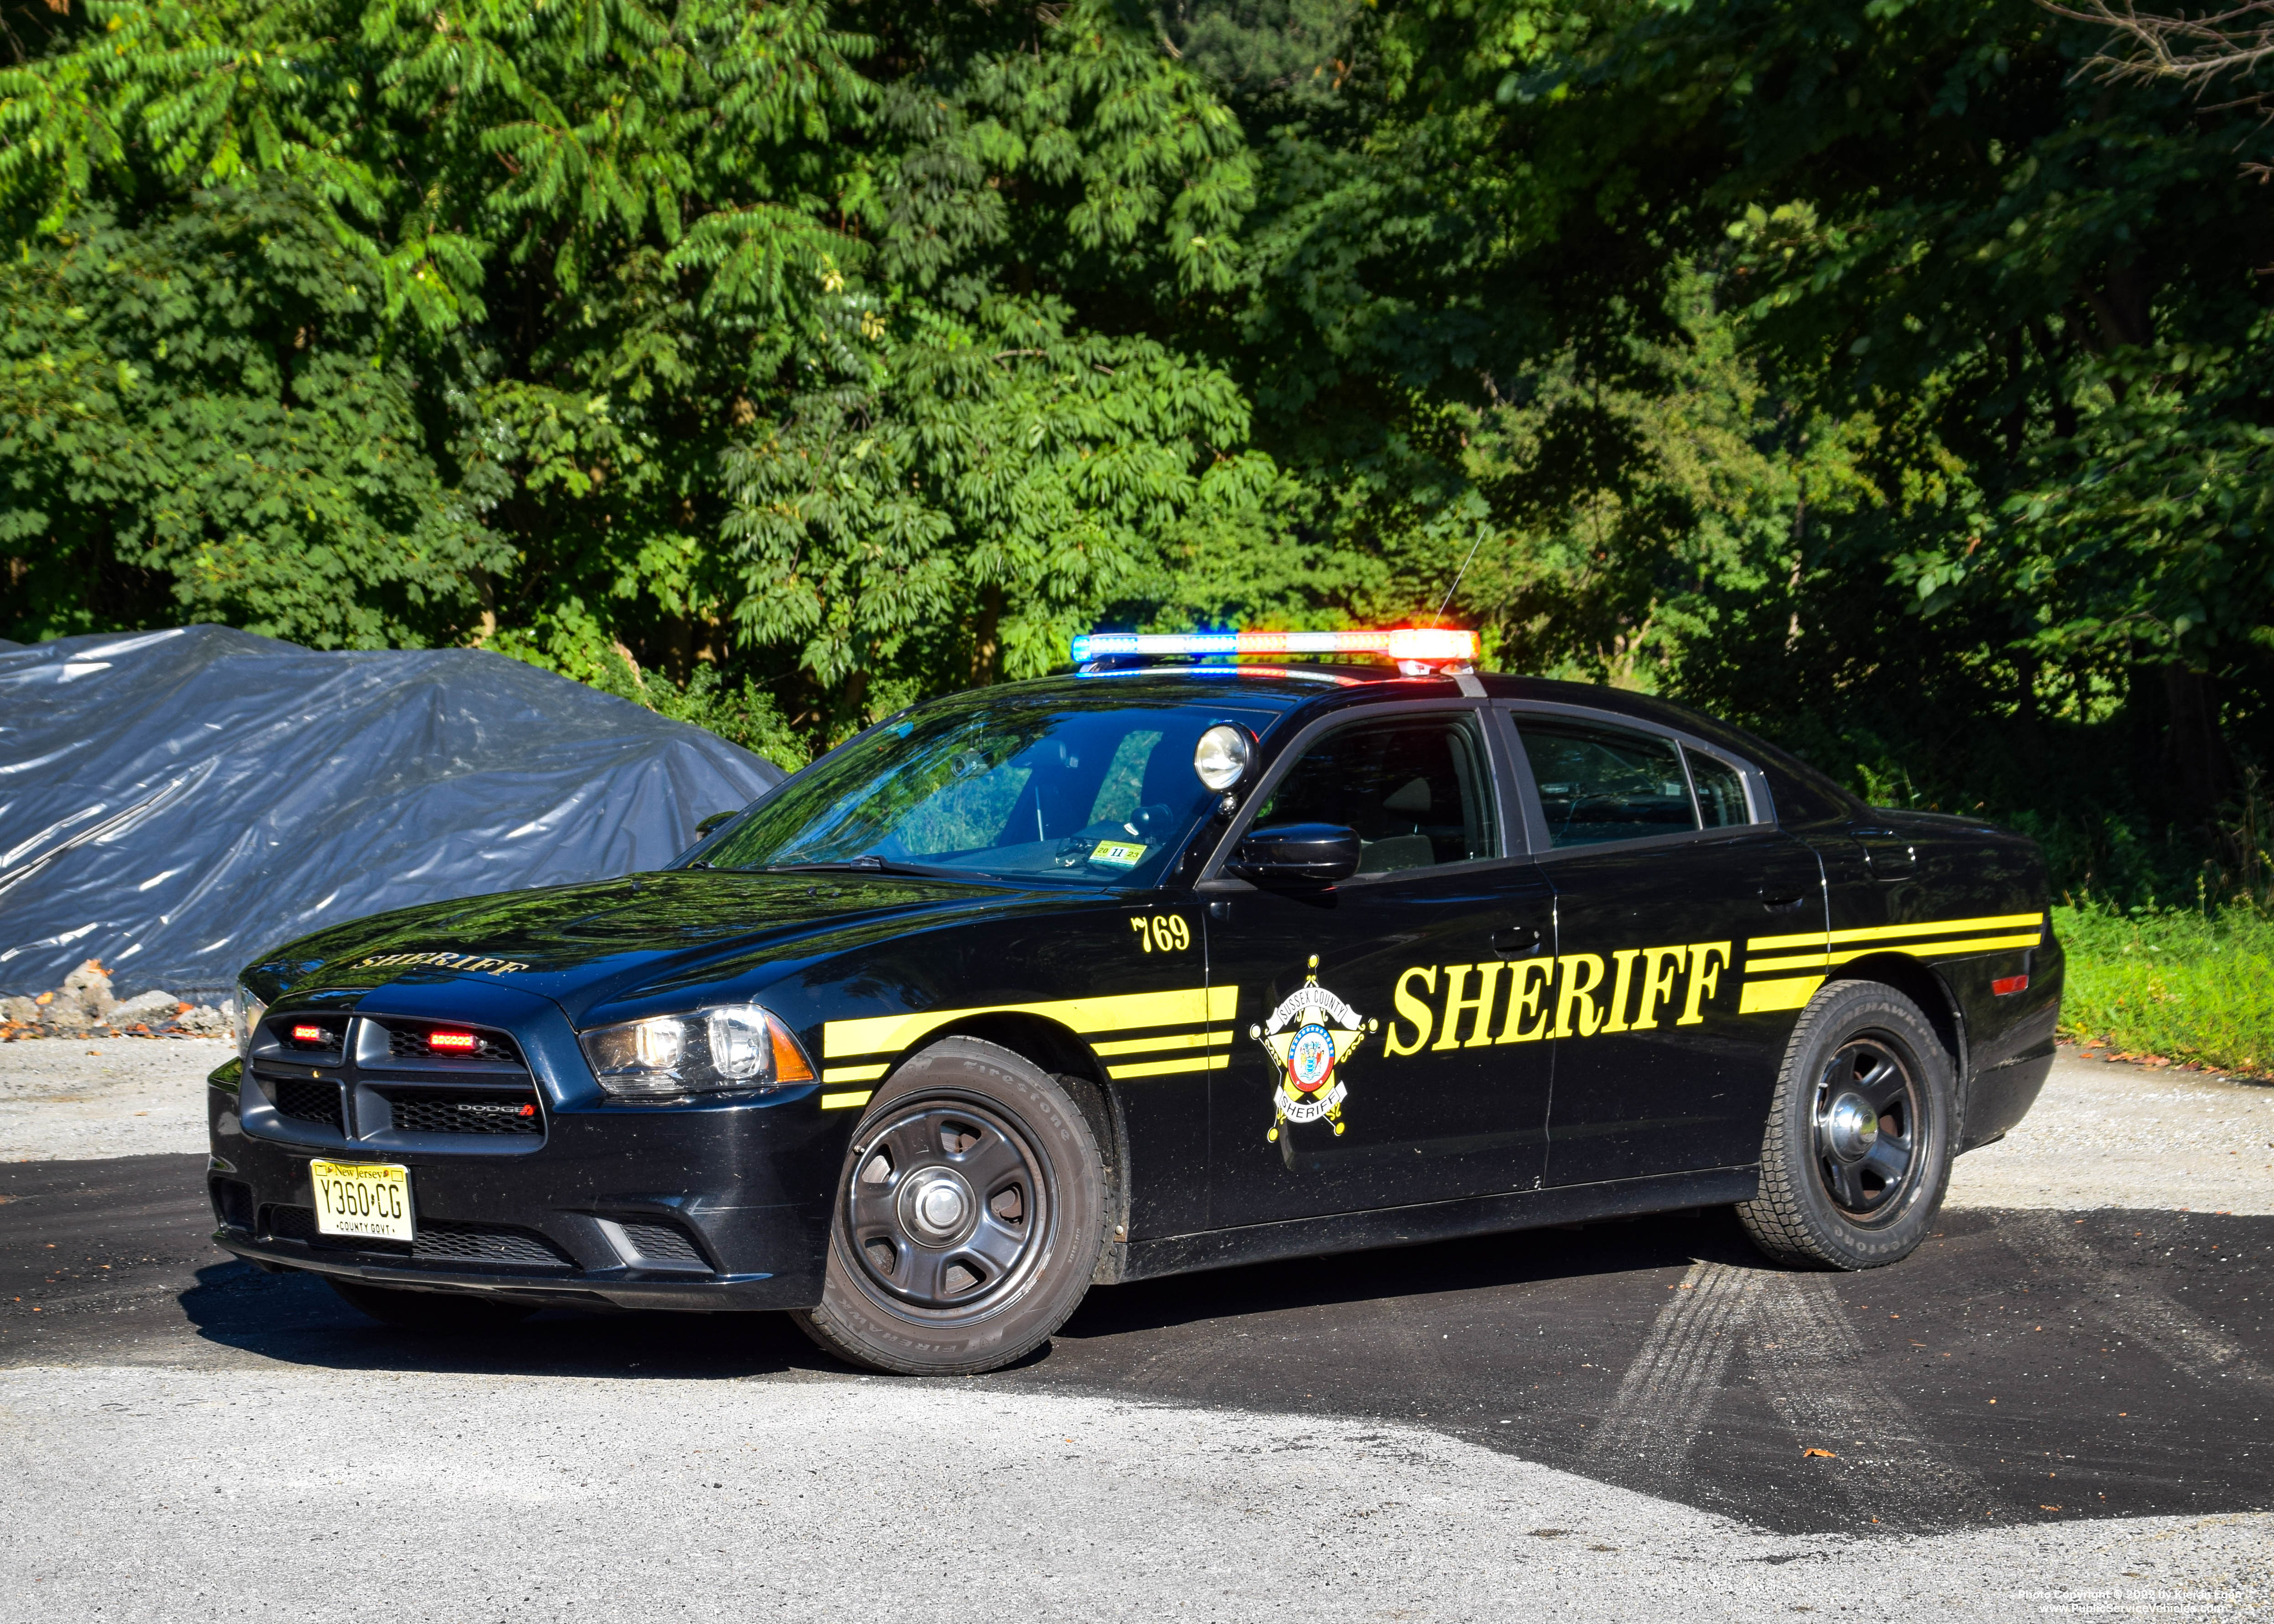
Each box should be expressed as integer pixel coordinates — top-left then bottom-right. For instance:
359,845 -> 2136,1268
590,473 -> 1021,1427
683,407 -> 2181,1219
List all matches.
207,1062 -> 846,1310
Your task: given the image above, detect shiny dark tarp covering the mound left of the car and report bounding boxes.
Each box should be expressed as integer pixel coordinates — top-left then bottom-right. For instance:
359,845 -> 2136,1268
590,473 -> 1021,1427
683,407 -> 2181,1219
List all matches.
0,626 -> 782,994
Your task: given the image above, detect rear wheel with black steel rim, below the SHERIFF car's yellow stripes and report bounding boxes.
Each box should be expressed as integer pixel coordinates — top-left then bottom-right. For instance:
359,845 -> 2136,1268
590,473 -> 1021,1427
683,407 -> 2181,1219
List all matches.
1738,981 -> 1958,1269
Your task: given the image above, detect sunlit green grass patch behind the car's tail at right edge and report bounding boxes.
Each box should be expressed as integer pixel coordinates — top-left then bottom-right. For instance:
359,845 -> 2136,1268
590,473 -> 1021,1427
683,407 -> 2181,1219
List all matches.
2053,901 -> 2274,1076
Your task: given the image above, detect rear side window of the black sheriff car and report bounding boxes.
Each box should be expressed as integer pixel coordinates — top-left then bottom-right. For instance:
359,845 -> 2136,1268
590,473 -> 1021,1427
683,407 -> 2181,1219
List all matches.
1517,716 -> 1753,846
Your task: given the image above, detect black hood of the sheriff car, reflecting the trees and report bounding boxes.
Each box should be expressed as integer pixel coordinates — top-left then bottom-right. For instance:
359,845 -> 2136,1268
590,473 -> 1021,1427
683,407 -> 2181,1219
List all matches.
245,871 -> 1069,1021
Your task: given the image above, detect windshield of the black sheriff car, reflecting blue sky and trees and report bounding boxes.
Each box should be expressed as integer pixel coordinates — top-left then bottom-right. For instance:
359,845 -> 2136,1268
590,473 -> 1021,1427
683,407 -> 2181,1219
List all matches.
689,694 -> 1271,887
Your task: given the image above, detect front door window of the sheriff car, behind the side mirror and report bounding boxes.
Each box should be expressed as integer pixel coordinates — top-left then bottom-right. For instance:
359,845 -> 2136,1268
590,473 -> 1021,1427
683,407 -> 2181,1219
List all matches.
1253,712 -> 1501,873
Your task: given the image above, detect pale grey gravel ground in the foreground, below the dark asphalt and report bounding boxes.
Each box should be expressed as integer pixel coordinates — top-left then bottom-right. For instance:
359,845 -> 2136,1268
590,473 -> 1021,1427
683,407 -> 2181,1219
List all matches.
0,1367 -> 2274,1622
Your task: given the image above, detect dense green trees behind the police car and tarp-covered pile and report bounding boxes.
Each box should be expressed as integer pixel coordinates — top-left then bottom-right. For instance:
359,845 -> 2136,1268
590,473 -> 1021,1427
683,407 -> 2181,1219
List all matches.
0,0 -> 2274,901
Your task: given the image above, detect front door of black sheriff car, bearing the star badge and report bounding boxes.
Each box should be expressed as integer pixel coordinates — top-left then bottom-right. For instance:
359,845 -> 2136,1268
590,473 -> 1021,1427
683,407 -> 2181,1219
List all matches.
1203,707 -> 1553,1228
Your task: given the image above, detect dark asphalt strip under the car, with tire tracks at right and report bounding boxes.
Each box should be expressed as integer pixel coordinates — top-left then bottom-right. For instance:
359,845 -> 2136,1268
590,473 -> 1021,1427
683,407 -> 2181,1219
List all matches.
0,1156 -> 2274,1533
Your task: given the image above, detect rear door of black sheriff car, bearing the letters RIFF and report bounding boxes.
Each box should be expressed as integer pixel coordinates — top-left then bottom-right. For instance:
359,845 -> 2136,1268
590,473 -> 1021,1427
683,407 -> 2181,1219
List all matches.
1508,707 -> 1826,1185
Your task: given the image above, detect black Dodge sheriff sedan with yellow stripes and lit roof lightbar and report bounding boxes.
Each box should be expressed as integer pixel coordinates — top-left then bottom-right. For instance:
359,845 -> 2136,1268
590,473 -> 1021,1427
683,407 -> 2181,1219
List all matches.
209,632 -> 2060,1374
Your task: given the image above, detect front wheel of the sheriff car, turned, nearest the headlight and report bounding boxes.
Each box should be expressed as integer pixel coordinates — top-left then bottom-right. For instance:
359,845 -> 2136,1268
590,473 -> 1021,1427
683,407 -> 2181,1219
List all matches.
791,1037 -> 1105,1376
